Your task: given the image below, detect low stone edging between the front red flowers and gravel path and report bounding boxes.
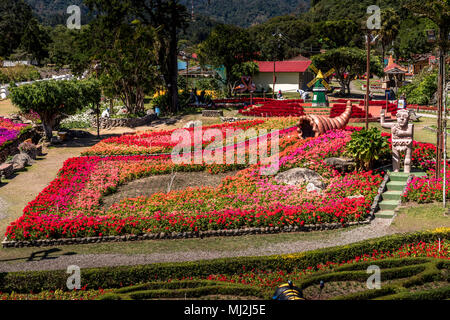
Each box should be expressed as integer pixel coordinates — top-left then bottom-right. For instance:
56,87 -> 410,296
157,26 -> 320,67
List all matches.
2,217 -> 372,248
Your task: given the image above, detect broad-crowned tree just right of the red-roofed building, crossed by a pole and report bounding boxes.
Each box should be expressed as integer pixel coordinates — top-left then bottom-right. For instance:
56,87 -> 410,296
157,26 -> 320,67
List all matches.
312,47 -> 383,94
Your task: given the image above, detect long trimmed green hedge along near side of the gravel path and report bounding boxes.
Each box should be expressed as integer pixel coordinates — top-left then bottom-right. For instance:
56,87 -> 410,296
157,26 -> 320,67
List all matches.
0,229 -> 450,293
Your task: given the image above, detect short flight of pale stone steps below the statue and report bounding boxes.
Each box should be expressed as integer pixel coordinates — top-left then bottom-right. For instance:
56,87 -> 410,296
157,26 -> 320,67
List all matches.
375,172 -> 426,219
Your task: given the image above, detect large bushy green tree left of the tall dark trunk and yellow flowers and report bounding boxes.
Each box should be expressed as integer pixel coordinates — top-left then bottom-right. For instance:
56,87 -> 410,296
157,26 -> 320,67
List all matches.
81,0 -> 160,114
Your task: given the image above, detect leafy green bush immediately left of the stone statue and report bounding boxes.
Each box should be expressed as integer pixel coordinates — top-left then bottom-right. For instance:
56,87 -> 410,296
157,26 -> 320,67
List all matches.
346,128 -> 389,170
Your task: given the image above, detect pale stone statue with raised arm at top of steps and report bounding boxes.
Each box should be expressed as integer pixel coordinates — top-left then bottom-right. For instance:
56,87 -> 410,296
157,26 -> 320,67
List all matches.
380,109 -> 414,173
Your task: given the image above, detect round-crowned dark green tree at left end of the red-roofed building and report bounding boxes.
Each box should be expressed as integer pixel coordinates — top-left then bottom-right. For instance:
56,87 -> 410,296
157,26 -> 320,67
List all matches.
199,25 -> 257,95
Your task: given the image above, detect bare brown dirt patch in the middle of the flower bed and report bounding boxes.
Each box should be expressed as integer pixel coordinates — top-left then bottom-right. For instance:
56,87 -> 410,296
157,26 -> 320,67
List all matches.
102,171 -> 237,209
